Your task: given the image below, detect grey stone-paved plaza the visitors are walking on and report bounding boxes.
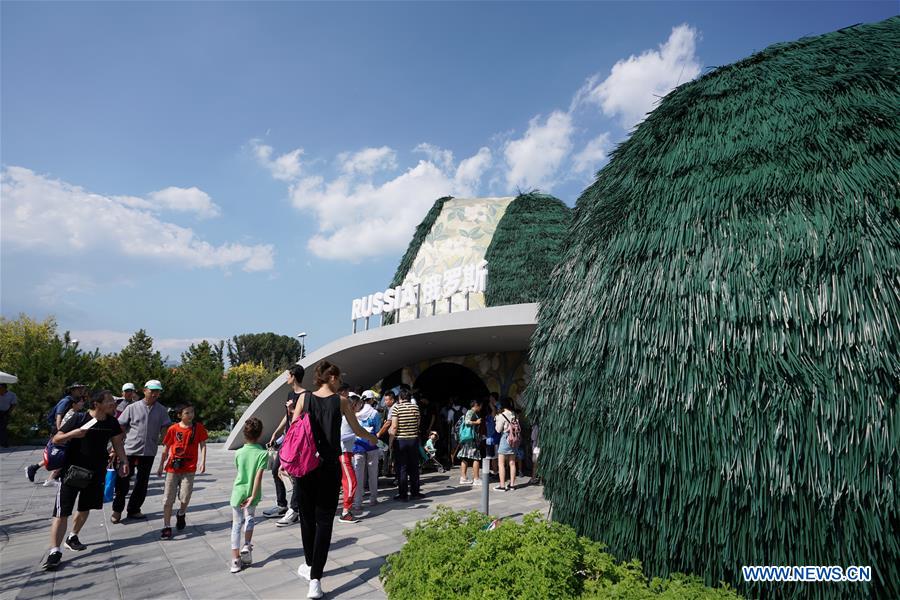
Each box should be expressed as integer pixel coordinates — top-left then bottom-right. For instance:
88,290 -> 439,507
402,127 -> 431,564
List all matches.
0,444 -> 549,600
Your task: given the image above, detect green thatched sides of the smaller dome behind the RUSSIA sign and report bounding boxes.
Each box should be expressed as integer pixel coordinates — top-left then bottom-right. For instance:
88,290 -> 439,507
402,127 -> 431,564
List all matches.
385,192 -> 572,314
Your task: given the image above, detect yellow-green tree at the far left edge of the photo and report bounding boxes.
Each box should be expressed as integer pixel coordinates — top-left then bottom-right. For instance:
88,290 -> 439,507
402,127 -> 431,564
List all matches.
0,315 -> 99,440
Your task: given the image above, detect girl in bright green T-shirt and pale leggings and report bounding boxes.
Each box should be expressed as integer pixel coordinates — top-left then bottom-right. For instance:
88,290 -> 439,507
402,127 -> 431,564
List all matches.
231,417 -> 269,573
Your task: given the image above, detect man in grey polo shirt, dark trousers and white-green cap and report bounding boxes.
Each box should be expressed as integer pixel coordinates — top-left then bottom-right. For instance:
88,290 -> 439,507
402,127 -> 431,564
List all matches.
111,379 -> 172,523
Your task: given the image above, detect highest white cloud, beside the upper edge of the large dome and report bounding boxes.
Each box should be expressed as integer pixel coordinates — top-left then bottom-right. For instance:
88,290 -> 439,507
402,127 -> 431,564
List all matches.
573,25 -> 700,128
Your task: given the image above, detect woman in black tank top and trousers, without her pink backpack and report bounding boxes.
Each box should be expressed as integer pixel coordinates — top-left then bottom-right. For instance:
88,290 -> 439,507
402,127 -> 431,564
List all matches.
294,360 -> 378,598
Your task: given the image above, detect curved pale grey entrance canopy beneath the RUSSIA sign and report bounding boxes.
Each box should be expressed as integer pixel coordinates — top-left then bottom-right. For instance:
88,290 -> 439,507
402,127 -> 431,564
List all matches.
226,304 -> 538,450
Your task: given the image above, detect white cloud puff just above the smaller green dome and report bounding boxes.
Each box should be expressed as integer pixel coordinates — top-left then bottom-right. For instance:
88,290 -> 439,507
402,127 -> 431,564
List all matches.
504,111 -> 574,191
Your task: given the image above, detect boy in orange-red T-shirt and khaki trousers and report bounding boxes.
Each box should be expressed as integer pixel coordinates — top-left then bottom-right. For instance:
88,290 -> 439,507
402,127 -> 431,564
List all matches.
156,404 -> 209,540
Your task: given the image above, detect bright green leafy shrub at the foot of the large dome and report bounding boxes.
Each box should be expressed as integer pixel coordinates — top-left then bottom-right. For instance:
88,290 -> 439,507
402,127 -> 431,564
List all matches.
381,506 -> 740,600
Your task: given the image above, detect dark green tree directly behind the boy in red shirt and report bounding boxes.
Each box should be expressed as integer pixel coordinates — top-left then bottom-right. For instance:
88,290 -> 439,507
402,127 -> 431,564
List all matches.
171,340 -> 239,429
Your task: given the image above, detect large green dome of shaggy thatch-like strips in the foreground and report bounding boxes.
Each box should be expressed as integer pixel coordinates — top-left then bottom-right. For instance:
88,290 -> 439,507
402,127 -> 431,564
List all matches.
526,18 -> 900,598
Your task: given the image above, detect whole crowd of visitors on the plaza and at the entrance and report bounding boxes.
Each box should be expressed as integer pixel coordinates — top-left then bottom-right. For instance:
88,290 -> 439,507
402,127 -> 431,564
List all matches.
17,361 -> 540,598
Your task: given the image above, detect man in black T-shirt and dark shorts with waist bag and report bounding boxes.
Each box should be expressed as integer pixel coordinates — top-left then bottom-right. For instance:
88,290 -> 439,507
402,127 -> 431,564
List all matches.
42,390 -> 128,571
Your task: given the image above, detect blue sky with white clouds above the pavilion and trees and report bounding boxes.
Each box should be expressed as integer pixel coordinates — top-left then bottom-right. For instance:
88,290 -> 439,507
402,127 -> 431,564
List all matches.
0,2 -> 897,358
